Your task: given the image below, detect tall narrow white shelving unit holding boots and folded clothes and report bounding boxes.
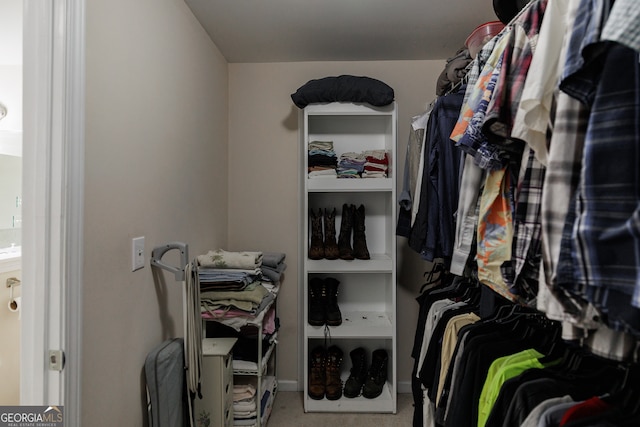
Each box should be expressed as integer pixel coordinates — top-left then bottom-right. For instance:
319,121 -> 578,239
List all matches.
300,103 -> 397,413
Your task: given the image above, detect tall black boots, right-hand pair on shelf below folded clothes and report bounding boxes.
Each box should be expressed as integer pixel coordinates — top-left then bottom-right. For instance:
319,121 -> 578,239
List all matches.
338,203 -> 371,260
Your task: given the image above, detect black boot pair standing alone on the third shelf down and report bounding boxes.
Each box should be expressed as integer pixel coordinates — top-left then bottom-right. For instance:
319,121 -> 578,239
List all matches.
307,277 -> 342,326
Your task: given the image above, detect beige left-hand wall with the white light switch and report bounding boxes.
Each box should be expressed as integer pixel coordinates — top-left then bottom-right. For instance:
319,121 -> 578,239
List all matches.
80,0 -> 228,427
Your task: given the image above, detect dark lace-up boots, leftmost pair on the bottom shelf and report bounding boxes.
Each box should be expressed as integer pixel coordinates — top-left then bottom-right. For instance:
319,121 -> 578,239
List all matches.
308,345 -> 342,400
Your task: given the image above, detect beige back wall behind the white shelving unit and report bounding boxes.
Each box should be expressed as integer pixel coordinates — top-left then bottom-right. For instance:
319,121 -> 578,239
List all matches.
229,61 -> 445,391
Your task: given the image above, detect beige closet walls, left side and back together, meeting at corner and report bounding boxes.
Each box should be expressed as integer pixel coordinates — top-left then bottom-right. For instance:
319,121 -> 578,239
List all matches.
81,0 -> 444,427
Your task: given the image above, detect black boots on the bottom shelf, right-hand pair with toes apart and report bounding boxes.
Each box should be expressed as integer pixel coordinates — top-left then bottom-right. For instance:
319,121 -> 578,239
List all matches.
344,347 -> 389,399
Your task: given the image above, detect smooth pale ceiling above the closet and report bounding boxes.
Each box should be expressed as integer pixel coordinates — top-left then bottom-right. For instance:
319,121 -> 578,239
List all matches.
185,0 -> 497,63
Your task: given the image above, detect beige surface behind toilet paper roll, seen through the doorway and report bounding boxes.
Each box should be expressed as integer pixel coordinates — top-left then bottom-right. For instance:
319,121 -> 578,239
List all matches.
0,270 -> 22,406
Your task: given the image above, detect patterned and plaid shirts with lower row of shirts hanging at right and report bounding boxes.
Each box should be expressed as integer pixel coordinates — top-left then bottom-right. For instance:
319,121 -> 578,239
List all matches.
404,0 -> 640,427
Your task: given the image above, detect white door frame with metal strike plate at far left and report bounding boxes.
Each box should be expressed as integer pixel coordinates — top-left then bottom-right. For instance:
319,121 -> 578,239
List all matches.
20,0 -> 85,426
